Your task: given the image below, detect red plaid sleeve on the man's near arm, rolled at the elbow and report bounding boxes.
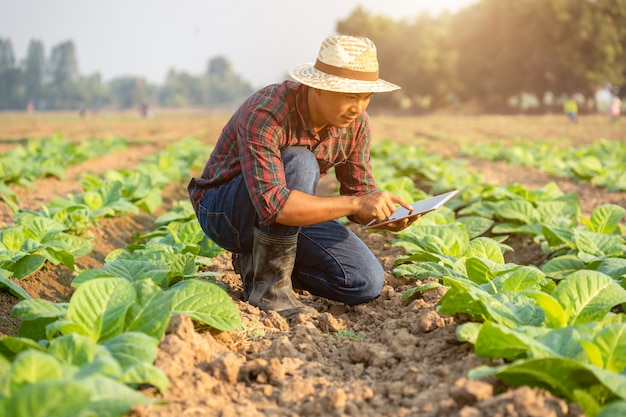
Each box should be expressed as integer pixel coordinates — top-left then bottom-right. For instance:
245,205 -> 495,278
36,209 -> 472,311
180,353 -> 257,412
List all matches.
237,109 -> 290,225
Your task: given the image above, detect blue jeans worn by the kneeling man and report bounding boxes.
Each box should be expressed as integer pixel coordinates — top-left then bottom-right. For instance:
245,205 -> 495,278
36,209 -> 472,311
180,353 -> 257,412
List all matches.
196,147 -> 384,305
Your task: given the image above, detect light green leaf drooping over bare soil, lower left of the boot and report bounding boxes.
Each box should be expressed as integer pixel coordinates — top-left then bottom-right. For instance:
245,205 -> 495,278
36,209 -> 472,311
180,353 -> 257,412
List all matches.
168,279 -> 242,331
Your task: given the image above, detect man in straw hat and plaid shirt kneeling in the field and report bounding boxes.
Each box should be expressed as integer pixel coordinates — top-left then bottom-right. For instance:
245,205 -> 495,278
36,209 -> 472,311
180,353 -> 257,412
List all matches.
189,36 -> 416,317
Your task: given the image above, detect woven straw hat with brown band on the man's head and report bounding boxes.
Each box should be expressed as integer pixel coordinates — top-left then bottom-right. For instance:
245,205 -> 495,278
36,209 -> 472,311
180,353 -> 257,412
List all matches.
289,36 -> 400,93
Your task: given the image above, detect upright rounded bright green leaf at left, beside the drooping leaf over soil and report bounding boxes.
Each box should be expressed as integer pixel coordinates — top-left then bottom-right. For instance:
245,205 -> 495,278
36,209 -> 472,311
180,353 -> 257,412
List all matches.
66,278 -> 135,341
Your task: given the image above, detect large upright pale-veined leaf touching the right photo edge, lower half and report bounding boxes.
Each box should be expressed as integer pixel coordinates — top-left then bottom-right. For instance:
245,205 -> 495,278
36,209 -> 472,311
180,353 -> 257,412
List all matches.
553,270 -> 626,325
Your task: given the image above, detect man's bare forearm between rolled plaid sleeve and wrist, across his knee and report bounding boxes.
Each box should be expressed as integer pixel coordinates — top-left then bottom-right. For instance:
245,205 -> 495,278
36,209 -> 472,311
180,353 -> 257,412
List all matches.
276,190 -> 359,226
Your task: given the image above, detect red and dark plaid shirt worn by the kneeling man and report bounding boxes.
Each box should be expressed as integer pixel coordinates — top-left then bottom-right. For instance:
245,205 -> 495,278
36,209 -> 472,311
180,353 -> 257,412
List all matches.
188,81 -> 376,225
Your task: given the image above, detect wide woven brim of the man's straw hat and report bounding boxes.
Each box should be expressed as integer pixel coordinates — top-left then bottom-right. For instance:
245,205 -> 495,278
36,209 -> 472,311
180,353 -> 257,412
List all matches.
289,64 -> 400,93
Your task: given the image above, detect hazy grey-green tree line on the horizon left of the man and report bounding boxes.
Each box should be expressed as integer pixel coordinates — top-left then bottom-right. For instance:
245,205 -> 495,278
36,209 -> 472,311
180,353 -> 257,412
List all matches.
0,38 -> 252,111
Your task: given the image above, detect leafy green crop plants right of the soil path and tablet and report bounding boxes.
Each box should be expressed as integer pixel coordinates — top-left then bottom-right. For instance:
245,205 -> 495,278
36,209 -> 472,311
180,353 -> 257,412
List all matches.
366,142 -> 626,417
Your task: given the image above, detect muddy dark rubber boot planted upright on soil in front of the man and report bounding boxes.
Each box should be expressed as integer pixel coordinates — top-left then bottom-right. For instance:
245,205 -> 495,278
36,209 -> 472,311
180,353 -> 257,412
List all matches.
248,228 -> 317,317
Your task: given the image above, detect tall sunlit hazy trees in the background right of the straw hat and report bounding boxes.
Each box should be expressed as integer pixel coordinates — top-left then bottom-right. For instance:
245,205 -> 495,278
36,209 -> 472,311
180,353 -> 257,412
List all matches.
337,0 -> 626,110
